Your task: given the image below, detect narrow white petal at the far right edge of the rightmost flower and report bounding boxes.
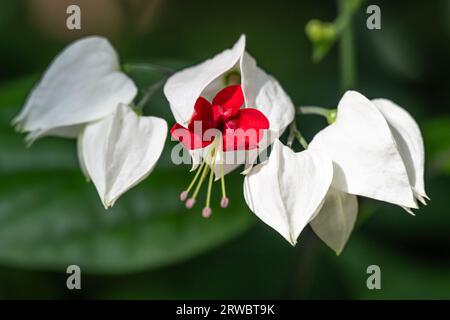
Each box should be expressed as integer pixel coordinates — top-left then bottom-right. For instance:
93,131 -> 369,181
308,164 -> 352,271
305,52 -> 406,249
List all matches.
372,99 -> 428,204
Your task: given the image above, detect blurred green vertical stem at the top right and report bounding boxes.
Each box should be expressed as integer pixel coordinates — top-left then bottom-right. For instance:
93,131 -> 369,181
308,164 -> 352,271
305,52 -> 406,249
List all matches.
338,0 -> 356,91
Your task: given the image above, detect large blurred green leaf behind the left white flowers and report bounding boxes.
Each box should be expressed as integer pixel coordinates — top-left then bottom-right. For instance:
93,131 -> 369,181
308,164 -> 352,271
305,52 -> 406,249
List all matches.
0,79 -> 255,273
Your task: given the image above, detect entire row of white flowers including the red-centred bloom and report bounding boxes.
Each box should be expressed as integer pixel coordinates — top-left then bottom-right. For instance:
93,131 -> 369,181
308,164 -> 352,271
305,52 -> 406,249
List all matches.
14,36 -> 428,253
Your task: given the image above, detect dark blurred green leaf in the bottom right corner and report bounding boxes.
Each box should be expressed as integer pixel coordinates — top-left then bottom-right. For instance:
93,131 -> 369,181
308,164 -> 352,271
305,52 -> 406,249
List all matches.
327,235 -> 450,299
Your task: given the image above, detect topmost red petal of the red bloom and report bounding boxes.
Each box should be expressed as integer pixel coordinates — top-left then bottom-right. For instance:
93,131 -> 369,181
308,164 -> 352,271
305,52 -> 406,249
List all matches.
212,84 -> 244,120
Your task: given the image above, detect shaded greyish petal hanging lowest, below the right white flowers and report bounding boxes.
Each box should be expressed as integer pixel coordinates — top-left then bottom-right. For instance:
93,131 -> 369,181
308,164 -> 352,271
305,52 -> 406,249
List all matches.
310,187 -> 358,255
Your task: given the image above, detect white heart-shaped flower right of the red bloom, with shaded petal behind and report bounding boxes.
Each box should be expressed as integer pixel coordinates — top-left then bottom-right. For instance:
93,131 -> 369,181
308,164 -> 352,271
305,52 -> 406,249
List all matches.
244,140 -> 358,254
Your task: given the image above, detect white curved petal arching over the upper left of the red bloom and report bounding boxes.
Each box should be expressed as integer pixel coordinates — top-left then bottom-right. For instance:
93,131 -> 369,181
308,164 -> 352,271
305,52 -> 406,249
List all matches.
164,35 -> 245,124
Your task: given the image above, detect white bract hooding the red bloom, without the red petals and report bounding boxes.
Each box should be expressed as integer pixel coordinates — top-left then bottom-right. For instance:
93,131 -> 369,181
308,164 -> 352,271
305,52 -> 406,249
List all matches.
164,35 -> 295,178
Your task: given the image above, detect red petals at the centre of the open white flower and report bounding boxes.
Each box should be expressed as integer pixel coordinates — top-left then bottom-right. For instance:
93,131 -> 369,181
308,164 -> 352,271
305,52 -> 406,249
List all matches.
170,85 -> 269,151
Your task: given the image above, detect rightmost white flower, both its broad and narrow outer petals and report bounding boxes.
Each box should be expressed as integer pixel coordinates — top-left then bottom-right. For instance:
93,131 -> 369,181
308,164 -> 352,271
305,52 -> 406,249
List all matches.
309,91 -> 428,212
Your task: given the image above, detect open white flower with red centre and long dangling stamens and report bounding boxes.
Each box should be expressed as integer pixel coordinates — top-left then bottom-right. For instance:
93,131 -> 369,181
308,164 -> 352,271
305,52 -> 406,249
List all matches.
164,36 -> 295,217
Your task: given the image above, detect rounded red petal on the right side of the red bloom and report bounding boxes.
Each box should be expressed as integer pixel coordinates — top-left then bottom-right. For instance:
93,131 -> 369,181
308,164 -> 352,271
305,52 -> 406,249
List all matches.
223,108 -> 269,151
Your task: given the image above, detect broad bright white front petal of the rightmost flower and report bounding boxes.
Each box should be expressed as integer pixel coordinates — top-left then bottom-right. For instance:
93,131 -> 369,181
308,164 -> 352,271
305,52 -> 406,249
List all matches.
309,91 -> 417,208
